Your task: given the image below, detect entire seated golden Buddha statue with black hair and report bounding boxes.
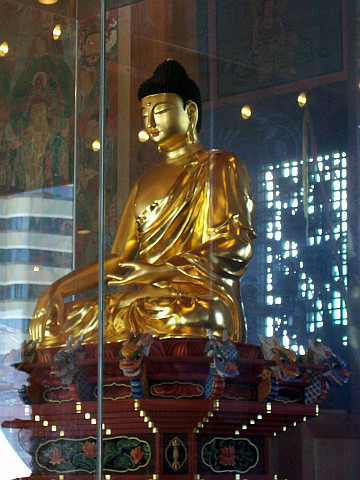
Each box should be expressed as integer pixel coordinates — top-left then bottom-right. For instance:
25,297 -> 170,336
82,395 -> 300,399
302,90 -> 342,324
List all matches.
30,60 -> 255,347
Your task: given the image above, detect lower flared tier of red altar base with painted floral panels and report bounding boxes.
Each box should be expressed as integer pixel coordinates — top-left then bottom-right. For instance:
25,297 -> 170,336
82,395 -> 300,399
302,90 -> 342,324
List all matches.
2,398 -> 317,480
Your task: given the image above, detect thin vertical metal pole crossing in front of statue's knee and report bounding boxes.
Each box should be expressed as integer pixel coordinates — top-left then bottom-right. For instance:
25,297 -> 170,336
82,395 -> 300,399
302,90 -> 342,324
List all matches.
96,0 -> 106,480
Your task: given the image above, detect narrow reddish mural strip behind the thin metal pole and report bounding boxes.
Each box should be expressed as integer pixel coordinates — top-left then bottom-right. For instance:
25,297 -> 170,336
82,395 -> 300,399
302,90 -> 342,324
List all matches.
76,11 -> 118,266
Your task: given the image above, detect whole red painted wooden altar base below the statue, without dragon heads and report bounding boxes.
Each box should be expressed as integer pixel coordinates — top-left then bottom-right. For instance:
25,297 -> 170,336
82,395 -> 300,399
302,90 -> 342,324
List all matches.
0,339 -> 325,480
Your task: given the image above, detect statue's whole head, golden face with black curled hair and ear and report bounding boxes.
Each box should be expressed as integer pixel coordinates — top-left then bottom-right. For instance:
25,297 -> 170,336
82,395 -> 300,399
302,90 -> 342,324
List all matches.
138,60 -> 201,151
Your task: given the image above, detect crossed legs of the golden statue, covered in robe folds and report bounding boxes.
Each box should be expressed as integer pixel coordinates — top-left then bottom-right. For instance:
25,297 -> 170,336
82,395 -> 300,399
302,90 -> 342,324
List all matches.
47,291 -> 238,343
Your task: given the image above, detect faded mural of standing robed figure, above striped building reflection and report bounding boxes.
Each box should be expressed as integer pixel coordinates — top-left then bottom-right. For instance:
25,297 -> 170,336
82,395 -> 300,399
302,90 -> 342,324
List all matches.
0,2 -> 74,195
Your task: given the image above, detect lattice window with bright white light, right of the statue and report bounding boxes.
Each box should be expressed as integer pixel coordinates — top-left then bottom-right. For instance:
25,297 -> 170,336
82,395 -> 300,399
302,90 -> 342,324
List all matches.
254,152 -> 347,353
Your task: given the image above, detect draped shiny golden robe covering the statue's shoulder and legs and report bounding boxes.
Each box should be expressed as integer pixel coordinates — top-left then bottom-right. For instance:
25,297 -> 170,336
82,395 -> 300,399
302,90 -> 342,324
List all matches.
41,150 -> 255,346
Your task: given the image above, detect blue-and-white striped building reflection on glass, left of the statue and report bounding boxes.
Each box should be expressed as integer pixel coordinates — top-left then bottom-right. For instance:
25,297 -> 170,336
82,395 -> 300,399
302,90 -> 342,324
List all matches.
0,185 -> 73,351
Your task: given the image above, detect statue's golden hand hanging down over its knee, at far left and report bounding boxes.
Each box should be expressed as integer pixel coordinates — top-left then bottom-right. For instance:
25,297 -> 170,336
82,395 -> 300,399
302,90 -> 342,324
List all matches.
29,282 -> 64,341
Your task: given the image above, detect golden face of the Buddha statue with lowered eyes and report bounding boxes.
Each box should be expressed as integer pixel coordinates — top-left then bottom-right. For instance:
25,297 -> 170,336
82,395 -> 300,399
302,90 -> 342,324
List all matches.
141,93 -> 190,151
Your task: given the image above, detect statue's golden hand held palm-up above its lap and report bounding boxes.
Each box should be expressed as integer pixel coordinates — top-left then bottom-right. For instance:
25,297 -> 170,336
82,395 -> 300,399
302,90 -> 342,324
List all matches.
107,262 -> 178,285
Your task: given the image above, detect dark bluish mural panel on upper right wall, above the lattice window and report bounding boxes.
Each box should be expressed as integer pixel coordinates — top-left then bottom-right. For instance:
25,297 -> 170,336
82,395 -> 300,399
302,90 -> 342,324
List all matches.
216,0 -> 344,97
